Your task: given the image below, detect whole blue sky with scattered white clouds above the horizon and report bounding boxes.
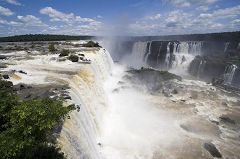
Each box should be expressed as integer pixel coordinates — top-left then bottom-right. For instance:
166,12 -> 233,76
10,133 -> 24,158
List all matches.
0,0 -> 240,36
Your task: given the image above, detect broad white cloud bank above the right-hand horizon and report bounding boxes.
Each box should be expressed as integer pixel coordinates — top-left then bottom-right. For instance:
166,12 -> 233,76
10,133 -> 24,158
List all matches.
129,5 -> 240,35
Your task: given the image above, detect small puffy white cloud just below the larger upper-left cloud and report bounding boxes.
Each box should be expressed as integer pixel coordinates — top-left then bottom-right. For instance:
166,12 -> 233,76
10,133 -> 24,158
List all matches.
17,15 -> 46,26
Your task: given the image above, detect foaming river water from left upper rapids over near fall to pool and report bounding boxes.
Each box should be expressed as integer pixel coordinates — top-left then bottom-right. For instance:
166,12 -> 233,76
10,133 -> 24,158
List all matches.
2,41 -> 240,159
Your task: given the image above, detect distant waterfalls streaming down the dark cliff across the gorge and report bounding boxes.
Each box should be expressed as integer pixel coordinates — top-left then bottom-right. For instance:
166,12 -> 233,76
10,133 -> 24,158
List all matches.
127,42 -> 202,72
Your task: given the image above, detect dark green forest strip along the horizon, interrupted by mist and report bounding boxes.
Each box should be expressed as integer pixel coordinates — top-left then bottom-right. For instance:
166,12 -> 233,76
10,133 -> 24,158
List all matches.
0,31 -> 240,42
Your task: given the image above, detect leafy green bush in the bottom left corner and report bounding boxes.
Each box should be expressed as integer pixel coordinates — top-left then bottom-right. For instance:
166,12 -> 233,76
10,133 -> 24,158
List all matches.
0,80 -> 74,159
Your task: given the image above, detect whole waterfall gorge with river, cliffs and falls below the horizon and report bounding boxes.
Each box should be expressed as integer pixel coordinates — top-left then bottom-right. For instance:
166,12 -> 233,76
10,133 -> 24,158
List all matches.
0,33 -> 240,159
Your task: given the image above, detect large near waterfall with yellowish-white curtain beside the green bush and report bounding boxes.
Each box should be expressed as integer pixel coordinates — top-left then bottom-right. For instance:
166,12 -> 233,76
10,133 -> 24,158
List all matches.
58,49 -> 113,159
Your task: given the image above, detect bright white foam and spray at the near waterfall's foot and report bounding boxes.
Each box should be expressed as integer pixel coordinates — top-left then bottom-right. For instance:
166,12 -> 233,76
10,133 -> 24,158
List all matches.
100,65 -> 180,159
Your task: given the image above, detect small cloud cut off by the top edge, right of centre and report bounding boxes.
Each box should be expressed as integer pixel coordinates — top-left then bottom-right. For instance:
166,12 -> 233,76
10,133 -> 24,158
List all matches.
163,0 -> 218,7
